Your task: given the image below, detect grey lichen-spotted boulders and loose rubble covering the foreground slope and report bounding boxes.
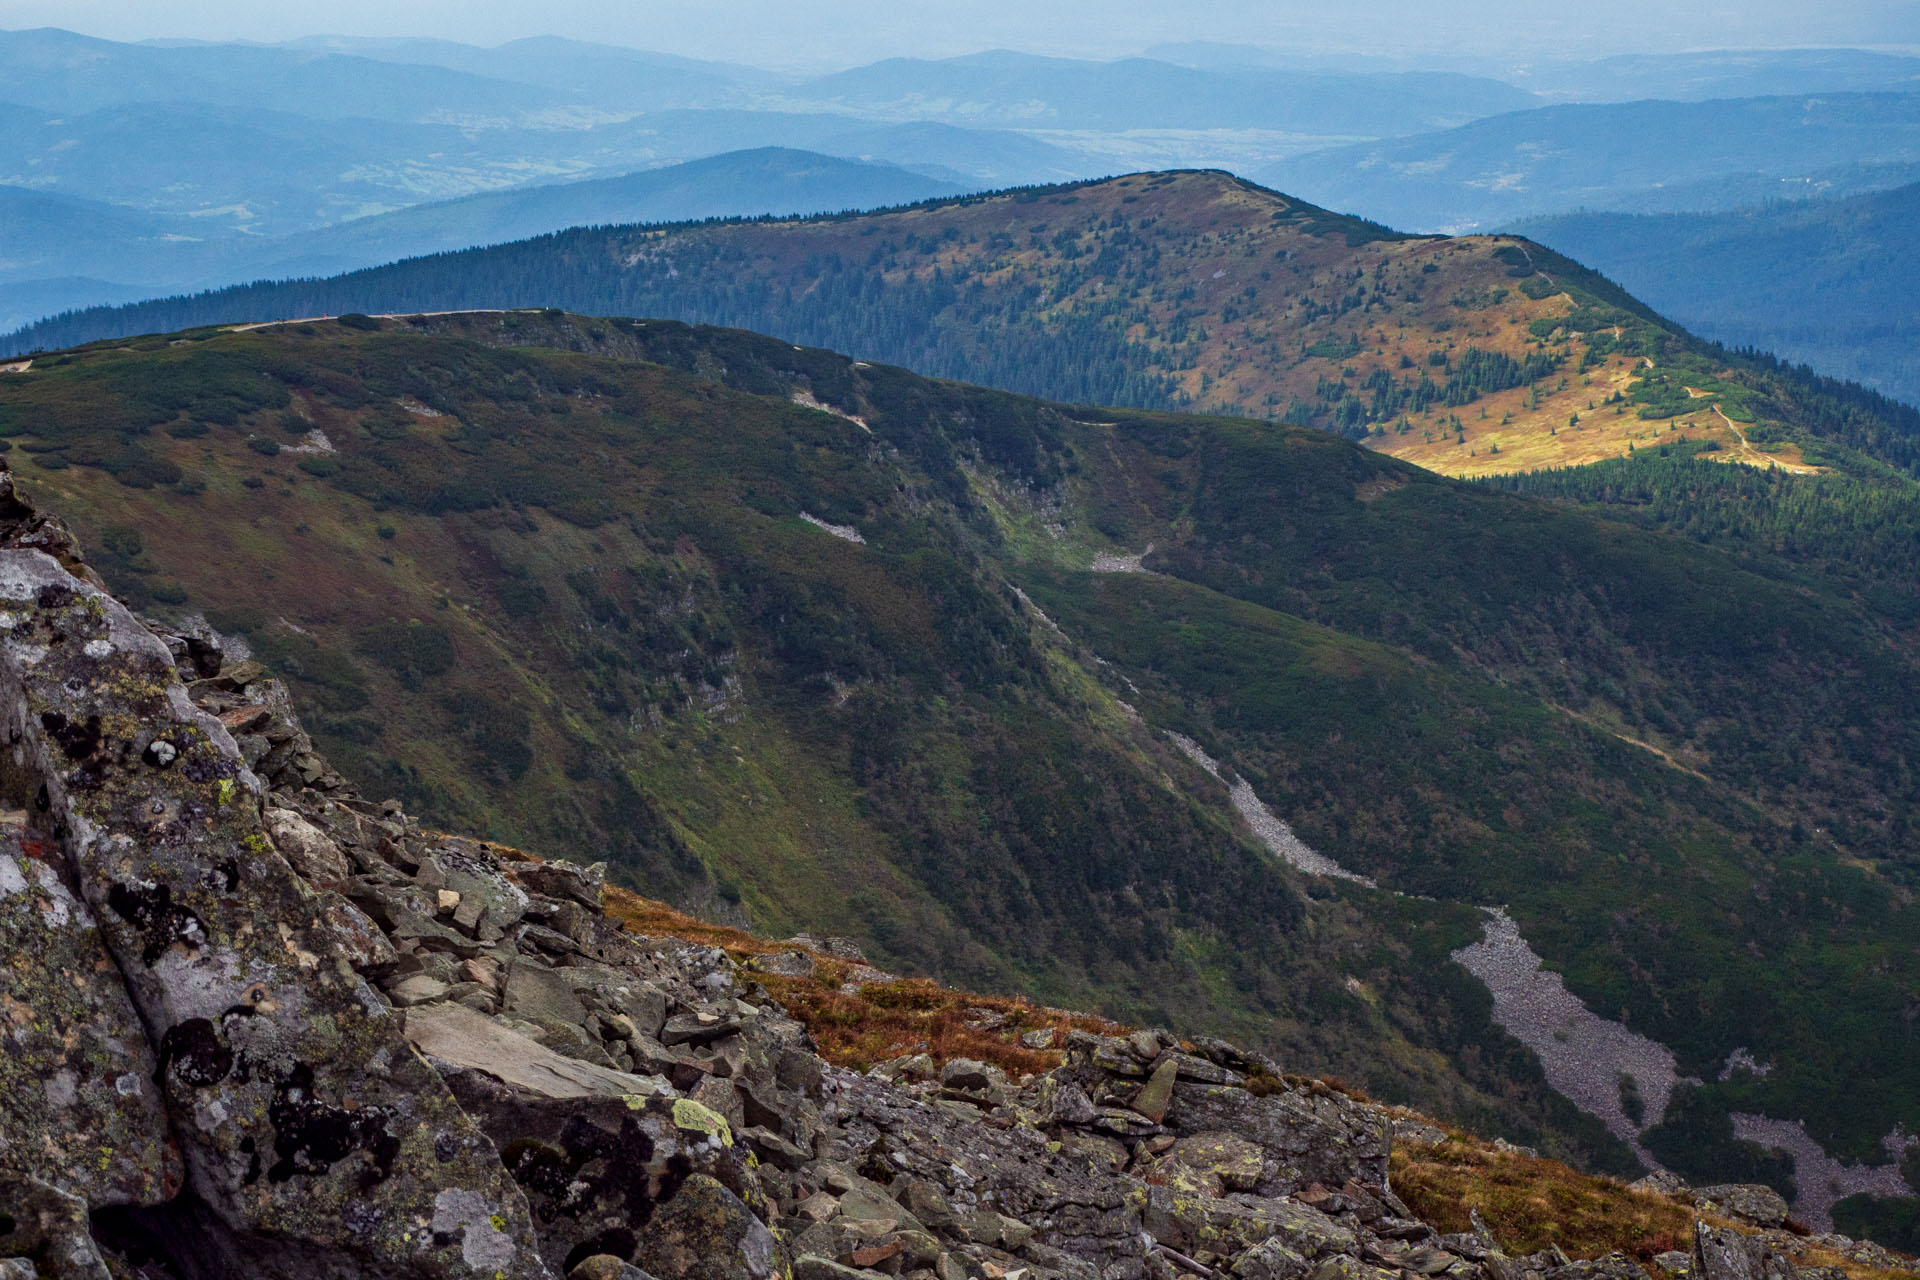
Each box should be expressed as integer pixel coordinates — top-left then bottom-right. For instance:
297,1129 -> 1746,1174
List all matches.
0,460 -> 1907,1280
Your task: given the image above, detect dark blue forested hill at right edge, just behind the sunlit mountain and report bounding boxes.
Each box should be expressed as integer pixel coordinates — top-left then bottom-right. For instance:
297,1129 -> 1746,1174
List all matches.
1515,184 -> 1920,403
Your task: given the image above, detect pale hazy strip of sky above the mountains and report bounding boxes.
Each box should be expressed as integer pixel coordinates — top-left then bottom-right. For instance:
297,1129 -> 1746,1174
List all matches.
0,0 -> 1920,67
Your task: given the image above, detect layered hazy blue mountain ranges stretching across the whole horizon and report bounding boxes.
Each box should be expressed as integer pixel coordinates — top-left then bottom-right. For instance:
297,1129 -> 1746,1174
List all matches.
18,20 -> 1920,401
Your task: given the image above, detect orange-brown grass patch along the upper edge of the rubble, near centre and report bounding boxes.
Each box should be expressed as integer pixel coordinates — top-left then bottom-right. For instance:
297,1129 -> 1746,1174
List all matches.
607,885 -> 1125,1077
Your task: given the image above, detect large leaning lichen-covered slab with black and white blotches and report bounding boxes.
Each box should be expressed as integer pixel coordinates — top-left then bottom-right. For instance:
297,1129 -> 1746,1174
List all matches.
0,551 -> 545,1278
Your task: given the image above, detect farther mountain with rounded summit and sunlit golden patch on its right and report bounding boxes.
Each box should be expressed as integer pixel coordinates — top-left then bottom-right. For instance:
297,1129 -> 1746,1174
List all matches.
13,173 -> 1899,487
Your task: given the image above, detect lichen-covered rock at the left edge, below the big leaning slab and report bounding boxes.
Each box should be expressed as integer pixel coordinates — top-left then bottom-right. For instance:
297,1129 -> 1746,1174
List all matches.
0,825 -> 182,1209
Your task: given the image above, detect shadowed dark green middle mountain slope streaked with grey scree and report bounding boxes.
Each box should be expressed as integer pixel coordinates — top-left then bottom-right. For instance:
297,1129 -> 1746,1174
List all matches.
11,312 -> 1920,1213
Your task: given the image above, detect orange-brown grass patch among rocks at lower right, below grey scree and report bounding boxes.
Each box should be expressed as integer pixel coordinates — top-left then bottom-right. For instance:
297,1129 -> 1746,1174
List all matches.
1390,1134 -> 1695,1261
